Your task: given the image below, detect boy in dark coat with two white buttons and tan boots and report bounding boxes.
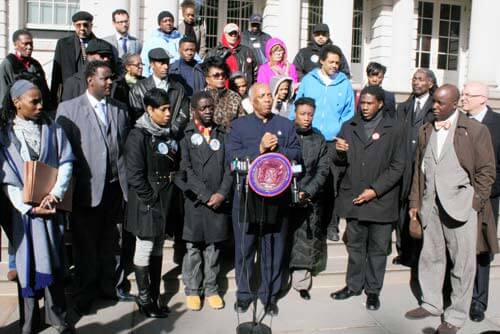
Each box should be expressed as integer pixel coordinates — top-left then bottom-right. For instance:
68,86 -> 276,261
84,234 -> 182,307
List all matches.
181,91 -> 233,311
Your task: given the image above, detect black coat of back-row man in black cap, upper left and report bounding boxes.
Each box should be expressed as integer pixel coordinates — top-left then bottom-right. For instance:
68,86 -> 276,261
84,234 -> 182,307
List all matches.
50,33 -> 97,105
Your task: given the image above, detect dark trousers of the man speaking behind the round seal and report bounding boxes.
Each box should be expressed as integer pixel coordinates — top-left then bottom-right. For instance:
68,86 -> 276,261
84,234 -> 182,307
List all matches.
233,218 -> 288,304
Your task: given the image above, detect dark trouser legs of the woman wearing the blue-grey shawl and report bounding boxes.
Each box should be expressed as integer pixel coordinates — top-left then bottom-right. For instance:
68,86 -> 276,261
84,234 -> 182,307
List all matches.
20,272 -> 67,334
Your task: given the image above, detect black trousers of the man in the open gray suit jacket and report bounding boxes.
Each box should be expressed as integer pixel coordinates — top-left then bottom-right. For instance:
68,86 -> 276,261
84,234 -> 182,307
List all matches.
71,182 -> 124,310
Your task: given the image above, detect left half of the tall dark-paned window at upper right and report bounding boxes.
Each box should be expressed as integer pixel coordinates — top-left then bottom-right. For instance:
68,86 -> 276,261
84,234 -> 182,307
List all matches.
415,1 -> 434,68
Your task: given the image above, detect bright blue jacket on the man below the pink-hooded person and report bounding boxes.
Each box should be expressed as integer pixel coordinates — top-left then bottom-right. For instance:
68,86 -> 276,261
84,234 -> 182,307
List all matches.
289,68 -> 354,141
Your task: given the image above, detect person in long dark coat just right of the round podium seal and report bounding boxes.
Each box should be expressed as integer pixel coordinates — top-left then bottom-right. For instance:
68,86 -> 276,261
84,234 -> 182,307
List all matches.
290,97 -> 330,300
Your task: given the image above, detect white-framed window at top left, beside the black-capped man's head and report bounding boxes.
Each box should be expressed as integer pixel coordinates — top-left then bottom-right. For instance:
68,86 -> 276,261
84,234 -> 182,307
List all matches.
26,0 -> 80,29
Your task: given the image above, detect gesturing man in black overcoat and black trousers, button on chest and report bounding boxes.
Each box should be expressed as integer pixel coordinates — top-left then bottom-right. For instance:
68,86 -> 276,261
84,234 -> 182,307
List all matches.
331,86 -> 405,310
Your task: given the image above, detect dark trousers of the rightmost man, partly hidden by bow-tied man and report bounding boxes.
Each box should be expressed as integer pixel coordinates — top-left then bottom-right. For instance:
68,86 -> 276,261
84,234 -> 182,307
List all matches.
472,197 -> 500,311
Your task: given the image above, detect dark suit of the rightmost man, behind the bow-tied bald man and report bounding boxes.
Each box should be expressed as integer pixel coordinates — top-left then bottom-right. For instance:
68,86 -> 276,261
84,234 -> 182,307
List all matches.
472,107 -> 500,311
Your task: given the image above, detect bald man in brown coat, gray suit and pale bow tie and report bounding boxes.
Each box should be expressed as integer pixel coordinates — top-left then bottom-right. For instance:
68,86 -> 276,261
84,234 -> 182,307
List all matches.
406,84 -> 496,334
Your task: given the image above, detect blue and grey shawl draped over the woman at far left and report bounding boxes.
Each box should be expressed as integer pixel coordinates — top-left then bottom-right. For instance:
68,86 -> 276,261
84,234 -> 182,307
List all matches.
0,123 -> 75,297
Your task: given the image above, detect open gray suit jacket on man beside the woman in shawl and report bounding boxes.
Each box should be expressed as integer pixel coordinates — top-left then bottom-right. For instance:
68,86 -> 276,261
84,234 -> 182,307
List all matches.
56,93 -> 129,207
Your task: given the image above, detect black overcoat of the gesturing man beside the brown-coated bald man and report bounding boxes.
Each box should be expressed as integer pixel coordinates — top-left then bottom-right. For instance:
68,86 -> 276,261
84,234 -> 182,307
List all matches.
333,114 -> 405,223
